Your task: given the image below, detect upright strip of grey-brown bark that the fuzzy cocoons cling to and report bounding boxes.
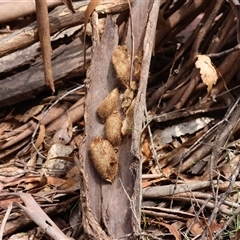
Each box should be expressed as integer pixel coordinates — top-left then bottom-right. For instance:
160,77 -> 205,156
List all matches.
79,0 -> 160,238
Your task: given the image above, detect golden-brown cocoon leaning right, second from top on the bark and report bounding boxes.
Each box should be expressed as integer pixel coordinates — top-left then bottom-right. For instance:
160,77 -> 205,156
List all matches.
97,88 -> 119,122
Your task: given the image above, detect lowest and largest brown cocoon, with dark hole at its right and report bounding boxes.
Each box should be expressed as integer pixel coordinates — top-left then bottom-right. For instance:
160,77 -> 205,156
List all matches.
90,137 -> 118,183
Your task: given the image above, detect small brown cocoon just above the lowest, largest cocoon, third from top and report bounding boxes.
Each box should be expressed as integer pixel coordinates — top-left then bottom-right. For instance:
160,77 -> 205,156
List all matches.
104,111 -> 122,147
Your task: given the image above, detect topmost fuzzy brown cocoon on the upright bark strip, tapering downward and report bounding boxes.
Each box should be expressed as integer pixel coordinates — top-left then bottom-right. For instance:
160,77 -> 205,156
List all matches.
112,45 -> 131,88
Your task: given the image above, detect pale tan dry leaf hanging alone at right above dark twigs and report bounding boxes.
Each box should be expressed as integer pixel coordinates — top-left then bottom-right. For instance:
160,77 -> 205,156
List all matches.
195,55 -> 218,93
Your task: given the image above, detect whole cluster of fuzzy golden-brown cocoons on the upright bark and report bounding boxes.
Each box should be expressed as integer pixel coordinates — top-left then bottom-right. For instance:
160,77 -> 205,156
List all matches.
90,45 -> 142,183
